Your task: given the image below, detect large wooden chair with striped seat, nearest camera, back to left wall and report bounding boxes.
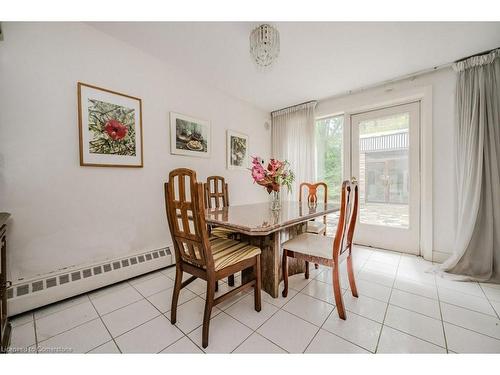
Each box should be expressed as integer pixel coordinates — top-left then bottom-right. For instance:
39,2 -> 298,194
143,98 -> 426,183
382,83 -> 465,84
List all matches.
165,168 -> 261,348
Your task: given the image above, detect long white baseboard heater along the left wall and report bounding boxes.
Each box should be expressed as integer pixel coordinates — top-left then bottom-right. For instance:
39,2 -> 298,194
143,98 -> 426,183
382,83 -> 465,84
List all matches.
7,247 -> 175,316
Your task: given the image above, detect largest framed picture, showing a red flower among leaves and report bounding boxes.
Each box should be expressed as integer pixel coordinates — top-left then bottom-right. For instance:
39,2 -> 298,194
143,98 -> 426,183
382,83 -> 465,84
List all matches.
78,82 -> 143,168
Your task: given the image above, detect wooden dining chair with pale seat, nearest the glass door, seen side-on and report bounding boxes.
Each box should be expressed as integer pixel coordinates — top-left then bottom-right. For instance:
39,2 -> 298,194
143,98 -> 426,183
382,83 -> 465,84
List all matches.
282,181 -> 358,319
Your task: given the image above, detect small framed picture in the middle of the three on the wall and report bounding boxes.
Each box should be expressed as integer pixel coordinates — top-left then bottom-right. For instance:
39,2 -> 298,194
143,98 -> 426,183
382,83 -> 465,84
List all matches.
170,112 -> 211,158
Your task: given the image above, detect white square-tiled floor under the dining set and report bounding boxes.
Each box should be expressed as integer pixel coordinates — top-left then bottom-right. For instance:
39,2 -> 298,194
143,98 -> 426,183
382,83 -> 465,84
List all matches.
5,247 -> 500,353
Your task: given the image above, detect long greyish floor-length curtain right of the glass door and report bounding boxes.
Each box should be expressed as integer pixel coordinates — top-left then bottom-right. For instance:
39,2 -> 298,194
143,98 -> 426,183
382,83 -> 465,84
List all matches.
440,50 -> 500,283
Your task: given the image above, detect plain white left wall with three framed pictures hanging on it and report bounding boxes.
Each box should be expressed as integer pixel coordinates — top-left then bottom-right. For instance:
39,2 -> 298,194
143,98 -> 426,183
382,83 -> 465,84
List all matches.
0,23 -> 271,280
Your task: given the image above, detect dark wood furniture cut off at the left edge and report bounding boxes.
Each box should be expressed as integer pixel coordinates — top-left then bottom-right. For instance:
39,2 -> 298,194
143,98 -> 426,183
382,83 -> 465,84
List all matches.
0,212 -> 11,353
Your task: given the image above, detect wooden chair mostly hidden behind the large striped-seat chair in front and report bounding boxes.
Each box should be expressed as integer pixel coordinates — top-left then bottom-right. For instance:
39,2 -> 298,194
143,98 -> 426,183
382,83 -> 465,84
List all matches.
203,176 -> 238,291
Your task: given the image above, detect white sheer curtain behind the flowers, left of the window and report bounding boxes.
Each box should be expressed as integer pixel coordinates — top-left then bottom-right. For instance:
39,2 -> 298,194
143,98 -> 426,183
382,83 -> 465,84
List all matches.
272,102 -> 316,200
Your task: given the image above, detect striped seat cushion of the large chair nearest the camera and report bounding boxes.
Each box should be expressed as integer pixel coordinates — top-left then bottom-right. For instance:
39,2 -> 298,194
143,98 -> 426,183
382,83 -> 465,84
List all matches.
210,237 -> 261,271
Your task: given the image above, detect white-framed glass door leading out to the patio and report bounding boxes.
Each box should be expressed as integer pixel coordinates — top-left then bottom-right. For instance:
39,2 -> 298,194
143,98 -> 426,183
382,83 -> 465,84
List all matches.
351,102 -> 420,254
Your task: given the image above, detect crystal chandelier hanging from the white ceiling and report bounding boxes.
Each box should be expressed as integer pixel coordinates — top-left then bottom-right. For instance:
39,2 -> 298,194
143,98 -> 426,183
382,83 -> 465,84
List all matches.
250,24 -> 280,68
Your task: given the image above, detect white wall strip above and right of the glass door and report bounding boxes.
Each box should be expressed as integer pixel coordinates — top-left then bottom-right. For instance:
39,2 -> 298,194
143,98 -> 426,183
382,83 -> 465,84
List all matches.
316,68 -> 456,260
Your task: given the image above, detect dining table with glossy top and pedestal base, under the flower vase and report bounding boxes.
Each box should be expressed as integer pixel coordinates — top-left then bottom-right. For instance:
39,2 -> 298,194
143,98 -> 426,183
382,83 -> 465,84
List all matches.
206,201 -> 339,298
